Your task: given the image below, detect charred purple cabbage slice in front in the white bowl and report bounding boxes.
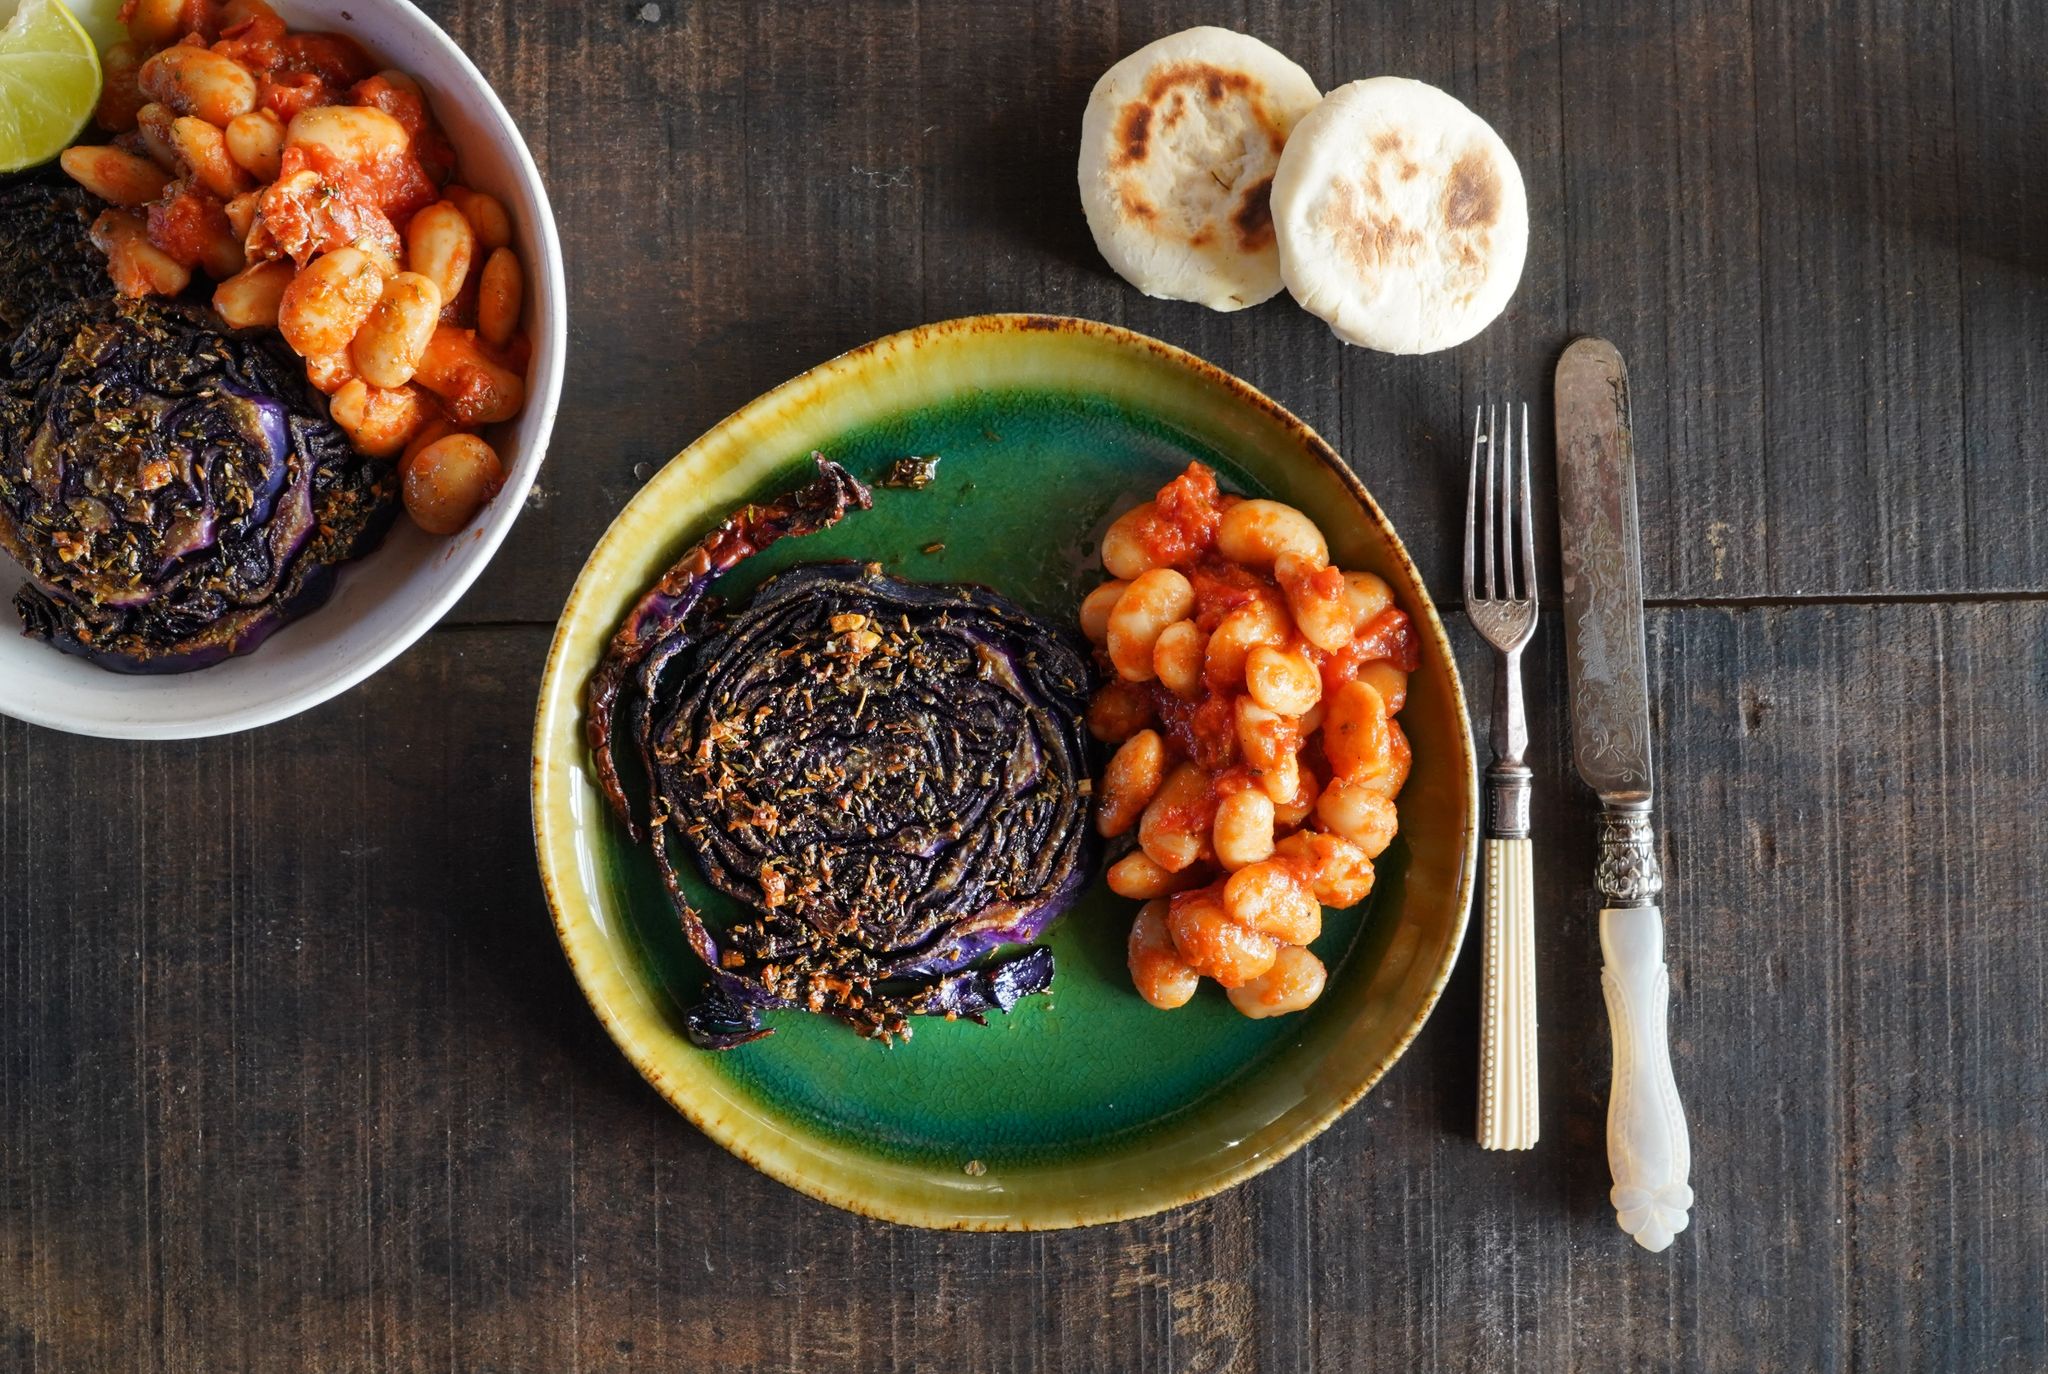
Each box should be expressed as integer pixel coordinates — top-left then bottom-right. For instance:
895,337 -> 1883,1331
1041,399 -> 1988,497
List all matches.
0,299 -> 397,672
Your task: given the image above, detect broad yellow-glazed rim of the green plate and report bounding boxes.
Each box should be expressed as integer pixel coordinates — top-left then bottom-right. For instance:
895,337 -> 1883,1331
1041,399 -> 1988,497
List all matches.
532,313 -> 1479,1231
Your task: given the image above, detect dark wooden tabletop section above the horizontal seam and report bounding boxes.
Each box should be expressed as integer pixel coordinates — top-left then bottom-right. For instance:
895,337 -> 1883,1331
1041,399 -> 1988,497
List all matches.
407,0 -> 2048,620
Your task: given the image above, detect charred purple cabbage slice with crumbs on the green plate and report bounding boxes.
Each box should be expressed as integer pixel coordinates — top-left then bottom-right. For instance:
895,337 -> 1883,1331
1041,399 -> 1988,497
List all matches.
590,461 -> 1096,1048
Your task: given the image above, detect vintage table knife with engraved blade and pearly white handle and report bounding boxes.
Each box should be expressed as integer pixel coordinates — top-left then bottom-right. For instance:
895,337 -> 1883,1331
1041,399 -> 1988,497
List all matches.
1556,338 -> 1692,1251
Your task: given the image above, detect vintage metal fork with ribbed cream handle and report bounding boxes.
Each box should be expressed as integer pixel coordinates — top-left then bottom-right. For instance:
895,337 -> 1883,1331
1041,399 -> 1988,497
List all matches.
1464,403 -> 1536,1149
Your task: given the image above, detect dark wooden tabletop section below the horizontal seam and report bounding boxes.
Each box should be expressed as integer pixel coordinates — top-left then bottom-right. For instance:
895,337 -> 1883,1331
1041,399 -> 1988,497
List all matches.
0,602 -> 2048,1372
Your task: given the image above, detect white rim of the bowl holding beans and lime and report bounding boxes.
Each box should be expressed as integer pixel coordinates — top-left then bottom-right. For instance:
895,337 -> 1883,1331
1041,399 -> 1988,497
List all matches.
0,0 -> 569,739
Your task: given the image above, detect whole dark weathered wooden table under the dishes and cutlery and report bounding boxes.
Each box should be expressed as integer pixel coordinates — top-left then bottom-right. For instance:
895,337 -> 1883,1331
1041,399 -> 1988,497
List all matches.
0,0 -> 2048,1374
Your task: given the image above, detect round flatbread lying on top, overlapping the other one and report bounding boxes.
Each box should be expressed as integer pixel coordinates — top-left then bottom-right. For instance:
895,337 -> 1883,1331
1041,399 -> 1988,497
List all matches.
1272,76 -> 1530,352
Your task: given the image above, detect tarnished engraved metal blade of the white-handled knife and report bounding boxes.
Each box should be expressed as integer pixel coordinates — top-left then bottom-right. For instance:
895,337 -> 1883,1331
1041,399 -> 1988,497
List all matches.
1556,338 -> 1651,803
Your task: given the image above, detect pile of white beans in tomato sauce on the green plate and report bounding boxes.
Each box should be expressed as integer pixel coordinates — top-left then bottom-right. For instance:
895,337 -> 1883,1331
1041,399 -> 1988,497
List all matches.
1081,465 -> 1419,1016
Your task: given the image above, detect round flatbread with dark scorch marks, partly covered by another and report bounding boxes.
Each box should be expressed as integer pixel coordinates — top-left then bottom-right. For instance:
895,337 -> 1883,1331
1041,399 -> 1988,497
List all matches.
1081,27 -> 1321,309
